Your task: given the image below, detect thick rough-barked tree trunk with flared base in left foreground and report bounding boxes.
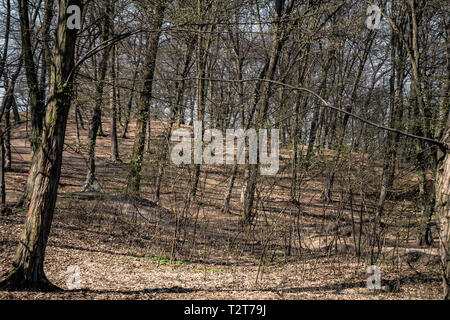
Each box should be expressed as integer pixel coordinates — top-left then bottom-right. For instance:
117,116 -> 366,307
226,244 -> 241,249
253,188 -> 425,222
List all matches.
0,0 -> 82,290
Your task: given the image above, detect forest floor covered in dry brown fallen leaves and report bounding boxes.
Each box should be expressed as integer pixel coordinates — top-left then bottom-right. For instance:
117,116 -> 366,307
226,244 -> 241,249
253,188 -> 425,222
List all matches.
0,111 -> 441,299
